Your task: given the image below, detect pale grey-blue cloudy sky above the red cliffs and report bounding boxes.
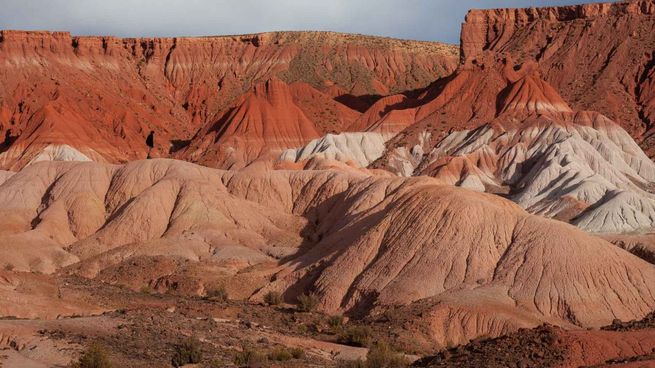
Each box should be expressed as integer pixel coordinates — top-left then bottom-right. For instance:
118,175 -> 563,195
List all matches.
0,0 -> 616,43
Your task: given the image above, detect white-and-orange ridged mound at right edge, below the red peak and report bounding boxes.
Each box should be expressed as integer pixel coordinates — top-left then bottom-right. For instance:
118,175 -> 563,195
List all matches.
410,113 -> 655,232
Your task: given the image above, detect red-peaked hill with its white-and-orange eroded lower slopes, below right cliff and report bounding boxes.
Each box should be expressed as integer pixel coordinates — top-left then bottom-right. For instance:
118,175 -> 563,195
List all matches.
288,54 -> 655,233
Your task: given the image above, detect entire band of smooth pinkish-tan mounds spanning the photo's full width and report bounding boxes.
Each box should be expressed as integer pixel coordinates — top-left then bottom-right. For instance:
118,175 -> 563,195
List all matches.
0,160 -> 655,346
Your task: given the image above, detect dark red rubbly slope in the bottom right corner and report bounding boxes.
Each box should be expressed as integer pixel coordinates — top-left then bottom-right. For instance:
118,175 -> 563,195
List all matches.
413,313 -> 655,368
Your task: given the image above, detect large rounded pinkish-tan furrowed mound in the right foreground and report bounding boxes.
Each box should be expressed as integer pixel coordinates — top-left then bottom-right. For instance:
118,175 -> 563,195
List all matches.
261,179 -> 653,344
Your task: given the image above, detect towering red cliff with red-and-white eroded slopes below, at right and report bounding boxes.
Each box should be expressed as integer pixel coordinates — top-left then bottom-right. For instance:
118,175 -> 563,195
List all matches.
272,1 -> 655,233
